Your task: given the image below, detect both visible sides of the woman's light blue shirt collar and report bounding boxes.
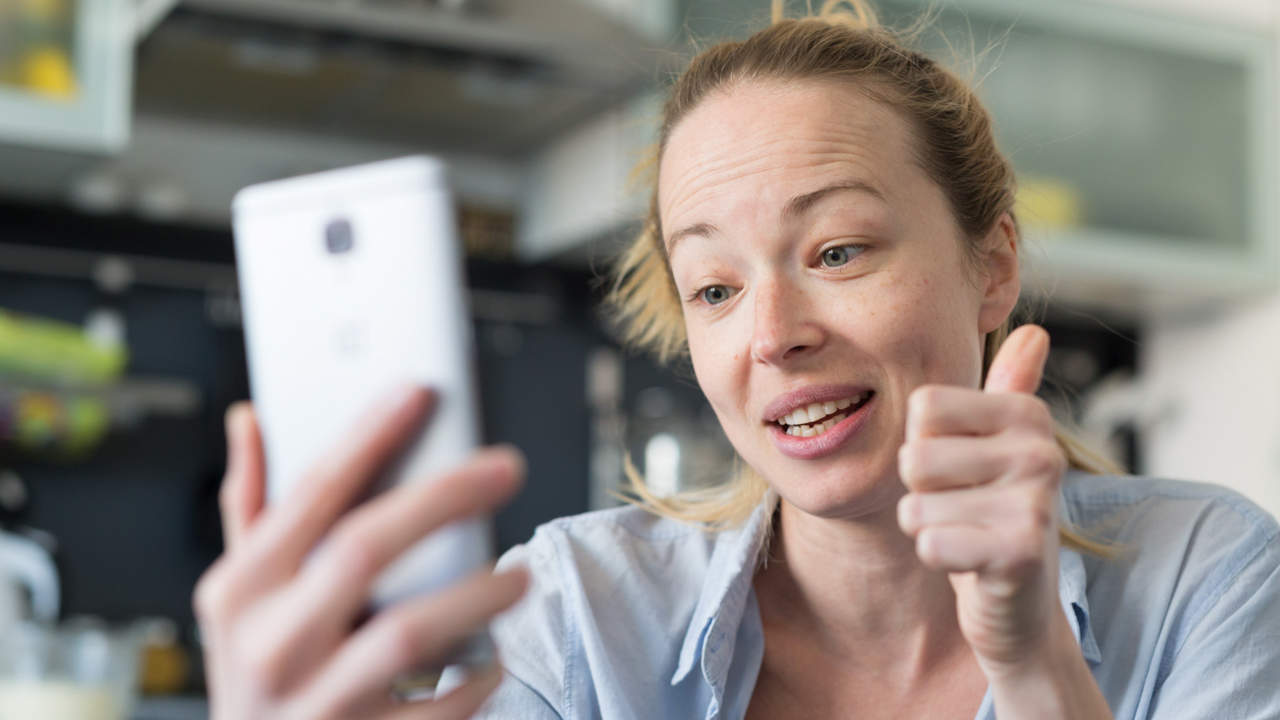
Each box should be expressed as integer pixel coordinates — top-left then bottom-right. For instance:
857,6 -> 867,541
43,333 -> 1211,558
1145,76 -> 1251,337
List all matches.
671,477 -> 1102,685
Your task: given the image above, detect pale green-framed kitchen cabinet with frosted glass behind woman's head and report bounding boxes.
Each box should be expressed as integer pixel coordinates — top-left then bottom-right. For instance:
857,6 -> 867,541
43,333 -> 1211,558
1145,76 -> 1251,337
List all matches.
888,0 -> 1280,313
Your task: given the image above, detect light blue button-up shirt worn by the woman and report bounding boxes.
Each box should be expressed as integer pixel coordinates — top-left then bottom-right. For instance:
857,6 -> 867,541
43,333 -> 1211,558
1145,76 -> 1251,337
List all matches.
465,471 -> 1280,720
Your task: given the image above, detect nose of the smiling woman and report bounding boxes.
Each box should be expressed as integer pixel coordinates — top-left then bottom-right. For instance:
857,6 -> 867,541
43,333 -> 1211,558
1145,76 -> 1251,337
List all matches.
751,274 -> 824,365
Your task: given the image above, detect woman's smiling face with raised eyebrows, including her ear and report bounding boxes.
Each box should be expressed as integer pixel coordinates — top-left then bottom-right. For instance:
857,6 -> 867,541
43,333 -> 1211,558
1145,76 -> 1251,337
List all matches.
658,81 -> 1018,518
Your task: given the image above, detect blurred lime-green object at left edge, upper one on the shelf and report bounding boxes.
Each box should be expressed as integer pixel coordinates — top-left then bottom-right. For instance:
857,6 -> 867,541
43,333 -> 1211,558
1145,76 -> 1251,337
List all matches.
0,310 -> 128,386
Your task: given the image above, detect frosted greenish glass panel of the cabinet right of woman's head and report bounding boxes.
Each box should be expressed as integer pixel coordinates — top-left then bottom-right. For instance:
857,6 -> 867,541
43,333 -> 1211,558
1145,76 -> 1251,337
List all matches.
885,0 -> 1258,249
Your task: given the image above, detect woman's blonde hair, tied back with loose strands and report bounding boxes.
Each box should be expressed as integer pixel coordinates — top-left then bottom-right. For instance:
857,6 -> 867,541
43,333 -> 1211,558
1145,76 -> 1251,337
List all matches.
608,0 -> 1123,556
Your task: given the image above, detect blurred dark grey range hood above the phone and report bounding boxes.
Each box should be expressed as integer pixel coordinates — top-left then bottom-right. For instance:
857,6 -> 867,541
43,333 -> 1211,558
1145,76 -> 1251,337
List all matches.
136,0 -> 660,158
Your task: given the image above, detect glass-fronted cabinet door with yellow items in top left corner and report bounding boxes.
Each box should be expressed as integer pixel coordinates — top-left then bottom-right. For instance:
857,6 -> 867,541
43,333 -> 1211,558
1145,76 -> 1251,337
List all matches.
0,0 -> 133,151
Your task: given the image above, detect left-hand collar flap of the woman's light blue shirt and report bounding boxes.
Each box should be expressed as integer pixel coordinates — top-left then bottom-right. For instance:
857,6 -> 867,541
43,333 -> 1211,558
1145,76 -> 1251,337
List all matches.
671,491 -> 778,685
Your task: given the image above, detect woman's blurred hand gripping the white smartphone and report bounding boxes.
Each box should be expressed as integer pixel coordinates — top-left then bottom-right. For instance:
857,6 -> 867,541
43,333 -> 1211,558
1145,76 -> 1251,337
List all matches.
195,389 -> 527,720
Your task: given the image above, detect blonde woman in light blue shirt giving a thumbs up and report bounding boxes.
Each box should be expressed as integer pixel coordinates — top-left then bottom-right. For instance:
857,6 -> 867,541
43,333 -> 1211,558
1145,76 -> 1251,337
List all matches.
197,3 -> 1280,719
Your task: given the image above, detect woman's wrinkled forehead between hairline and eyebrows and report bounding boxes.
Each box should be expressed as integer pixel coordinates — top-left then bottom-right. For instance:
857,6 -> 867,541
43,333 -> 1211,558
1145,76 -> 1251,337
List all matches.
658,81 -> 927,231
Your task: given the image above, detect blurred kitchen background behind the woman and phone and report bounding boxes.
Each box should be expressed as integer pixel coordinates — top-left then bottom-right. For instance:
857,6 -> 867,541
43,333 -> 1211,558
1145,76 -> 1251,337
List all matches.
0,0 -> 1280,717
